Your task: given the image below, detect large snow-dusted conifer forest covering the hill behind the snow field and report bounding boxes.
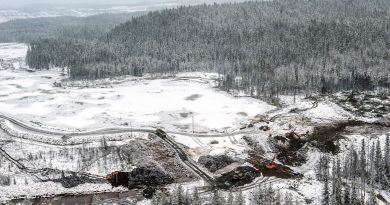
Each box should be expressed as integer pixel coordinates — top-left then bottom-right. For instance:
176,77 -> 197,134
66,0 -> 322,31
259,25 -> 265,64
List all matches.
27,0 -> 390,98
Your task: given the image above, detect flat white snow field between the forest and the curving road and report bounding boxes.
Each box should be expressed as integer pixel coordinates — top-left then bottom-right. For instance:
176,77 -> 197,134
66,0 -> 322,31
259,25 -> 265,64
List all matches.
0,44 -> 273,132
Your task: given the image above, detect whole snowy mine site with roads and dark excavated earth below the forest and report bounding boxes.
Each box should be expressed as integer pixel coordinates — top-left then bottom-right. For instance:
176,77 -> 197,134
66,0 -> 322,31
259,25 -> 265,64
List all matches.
0,44 -> 390,204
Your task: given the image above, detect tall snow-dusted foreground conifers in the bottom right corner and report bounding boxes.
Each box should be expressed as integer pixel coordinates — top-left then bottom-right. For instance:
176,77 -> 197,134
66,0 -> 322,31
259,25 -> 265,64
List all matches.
317,136 -> 390,205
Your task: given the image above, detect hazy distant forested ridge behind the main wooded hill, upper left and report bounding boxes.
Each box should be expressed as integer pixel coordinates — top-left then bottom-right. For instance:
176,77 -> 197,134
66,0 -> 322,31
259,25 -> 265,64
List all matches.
0,12 -> 144,43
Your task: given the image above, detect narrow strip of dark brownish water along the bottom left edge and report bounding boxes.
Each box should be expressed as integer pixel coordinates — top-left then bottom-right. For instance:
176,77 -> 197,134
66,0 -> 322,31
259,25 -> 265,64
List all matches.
6,191 -> 143,205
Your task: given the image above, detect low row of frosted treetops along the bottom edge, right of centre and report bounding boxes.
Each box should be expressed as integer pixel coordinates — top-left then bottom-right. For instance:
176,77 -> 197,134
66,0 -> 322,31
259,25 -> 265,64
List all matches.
151,184 -> 301,205
